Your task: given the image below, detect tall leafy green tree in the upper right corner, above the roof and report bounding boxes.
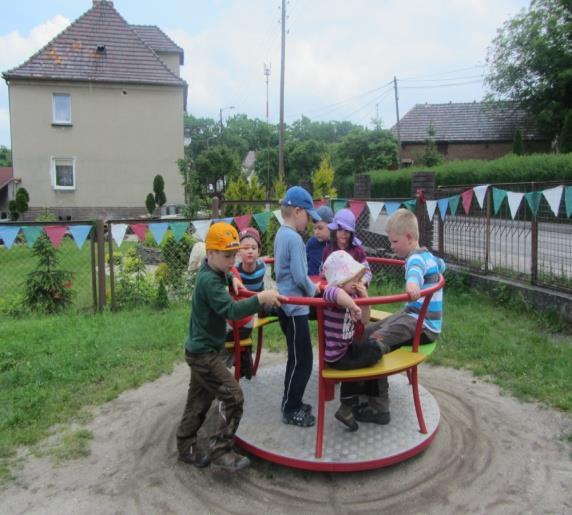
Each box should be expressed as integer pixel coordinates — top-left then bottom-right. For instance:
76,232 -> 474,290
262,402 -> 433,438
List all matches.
486,0 -> 572,136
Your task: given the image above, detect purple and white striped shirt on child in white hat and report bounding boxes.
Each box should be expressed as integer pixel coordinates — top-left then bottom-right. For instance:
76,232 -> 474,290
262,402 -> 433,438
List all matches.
324,286 -> 356,363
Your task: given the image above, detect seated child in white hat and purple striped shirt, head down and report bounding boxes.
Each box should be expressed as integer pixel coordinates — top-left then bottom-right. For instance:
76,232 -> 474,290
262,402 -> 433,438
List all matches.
323,250 -> 390,431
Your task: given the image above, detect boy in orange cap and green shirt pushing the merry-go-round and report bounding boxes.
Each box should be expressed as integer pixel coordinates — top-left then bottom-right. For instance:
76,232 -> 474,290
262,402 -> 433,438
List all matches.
177,222 -> 285,471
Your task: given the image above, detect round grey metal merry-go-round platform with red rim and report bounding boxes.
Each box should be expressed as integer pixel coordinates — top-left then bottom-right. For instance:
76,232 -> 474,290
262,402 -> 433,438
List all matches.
236,365 -> 440,472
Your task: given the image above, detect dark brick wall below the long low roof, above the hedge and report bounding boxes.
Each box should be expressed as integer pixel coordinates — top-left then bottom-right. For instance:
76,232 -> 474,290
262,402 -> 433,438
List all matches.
401,141 -> 550,161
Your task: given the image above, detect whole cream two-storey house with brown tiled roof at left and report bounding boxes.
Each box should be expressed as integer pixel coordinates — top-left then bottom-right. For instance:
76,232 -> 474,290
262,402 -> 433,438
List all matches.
3,0 -> 187,220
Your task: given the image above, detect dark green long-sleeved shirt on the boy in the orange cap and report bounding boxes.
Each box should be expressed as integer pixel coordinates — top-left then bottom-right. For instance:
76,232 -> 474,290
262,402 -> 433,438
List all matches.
185,262 -> 260,354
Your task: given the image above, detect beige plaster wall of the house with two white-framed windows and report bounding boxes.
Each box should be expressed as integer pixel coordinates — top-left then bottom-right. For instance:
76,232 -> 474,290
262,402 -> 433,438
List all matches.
9,81 -> 183,218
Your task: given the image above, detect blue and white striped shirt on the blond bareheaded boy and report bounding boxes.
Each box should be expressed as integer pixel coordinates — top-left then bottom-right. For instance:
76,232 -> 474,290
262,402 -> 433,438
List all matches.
405,248 -> 445,334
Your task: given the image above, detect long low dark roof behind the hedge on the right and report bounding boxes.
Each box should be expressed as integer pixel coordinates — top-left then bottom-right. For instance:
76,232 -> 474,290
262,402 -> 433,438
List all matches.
391,102 -> 549,143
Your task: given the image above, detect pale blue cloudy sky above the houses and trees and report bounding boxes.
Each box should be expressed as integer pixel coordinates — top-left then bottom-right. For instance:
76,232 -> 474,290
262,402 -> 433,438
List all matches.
0,0 -> 529,148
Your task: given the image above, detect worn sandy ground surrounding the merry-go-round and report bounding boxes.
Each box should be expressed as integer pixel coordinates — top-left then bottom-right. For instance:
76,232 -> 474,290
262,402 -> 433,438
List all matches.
0,354 -> 572,515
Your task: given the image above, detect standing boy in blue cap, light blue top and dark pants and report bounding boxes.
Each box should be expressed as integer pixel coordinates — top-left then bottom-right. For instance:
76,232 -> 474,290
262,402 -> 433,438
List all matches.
274,186 -> 321,427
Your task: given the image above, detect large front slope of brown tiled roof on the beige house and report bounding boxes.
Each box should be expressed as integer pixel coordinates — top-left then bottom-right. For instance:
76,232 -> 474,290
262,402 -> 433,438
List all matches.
3,0 -> 186,86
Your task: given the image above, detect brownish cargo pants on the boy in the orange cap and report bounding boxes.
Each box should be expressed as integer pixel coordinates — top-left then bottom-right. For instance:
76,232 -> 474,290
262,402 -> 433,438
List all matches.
177,352 -> 244,459
